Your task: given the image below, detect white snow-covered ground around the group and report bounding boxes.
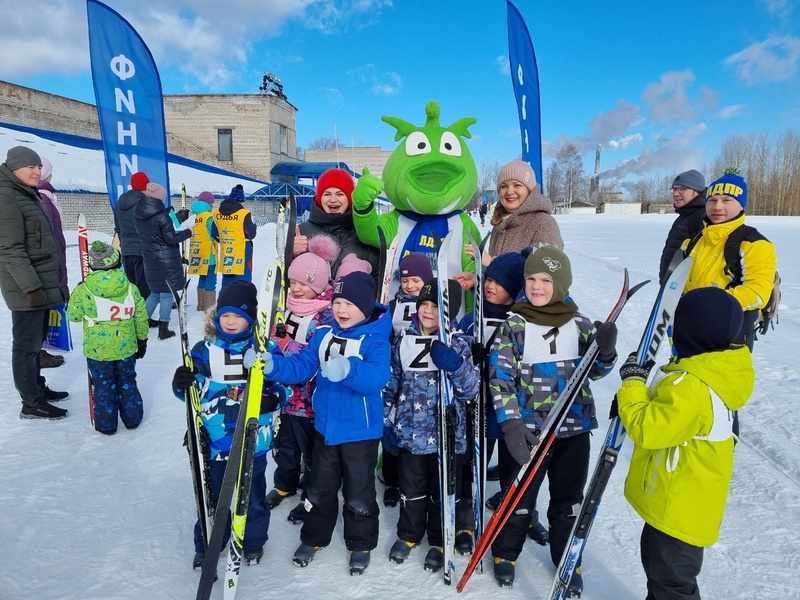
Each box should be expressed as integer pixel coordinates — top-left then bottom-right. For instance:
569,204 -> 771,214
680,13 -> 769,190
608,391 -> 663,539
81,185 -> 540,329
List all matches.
0,215 -> 800,600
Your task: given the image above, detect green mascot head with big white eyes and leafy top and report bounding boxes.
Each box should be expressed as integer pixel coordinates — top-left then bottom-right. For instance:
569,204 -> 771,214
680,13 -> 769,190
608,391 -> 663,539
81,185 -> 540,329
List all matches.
382,100 -> 478,215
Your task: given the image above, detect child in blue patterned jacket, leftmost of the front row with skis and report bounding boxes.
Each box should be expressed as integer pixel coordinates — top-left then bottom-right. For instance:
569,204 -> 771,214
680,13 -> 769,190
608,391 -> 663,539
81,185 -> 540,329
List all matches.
172,280 -> 286,568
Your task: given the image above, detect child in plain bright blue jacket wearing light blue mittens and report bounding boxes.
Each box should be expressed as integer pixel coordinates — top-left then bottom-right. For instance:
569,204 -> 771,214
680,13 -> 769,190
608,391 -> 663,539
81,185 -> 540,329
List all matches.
264,271 -> 392,575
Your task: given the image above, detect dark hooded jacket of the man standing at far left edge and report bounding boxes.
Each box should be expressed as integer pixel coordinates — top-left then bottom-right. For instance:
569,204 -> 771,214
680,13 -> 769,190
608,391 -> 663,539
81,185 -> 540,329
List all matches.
0,163 -> 64,311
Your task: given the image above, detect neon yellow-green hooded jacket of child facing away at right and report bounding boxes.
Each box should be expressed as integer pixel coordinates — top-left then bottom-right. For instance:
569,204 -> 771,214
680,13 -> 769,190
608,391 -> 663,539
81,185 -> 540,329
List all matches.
617,346 -> 755,546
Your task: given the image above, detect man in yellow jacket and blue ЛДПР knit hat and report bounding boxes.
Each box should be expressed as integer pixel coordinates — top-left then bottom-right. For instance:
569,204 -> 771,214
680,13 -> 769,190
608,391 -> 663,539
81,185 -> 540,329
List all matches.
684,173 -> 777,350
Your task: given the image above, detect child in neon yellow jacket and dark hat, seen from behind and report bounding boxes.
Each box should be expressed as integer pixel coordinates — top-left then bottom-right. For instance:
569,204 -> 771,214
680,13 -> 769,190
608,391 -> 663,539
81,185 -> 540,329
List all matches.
612,287 -> 755,600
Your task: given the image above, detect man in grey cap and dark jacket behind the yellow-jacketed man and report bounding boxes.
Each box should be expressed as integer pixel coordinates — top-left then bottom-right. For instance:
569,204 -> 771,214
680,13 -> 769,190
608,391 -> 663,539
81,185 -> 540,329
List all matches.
658,169 -> 706,284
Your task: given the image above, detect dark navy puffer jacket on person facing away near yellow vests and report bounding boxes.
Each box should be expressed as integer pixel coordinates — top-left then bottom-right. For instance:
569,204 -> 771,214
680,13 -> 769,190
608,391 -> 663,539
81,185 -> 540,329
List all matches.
136,196 -> 192,292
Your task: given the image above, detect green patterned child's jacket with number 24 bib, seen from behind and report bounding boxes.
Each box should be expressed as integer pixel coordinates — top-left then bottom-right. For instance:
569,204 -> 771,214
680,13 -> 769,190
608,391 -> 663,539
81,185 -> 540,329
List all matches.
67,269 -> 148,361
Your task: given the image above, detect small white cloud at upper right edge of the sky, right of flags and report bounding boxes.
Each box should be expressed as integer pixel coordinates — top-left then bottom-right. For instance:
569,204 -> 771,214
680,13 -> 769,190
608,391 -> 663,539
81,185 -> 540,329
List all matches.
725,35 -> 800,85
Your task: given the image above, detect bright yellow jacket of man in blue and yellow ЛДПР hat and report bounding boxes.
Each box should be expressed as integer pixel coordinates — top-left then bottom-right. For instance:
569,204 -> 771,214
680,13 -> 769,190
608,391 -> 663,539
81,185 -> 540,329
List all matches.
683,213 -> 777,311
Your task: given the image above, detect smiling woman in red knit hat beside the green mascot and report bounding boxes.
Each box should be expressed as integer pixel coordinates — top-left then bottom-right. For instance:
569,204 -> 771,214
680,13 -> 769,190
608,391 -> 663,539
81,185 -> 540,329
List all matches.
293,169 -> 378,275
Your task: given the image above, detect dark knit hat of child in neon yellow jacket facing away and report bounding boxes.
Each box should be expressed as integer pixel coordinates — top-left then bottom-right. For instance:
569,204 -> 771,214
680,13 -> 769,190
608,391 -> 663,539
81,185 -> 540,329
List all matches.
672,287 -> 744,358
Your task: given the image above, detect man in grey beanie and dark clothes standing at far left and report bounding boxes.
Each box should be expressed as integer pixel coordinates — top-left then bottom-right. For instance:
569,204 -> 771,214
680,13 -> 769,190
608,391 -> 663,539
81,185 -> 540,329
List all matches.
0,146 -> 69,419
